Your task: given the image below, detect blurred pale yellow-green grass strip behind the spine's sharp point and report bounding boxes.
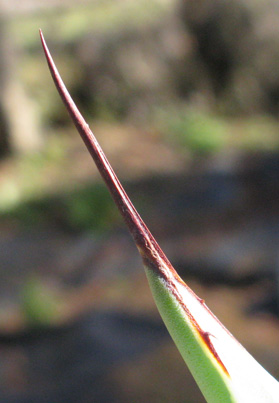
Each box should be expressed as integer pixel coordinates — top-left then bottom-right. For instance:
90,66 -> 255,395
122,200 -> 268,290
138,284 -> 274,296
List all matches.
11,0 -> 173,47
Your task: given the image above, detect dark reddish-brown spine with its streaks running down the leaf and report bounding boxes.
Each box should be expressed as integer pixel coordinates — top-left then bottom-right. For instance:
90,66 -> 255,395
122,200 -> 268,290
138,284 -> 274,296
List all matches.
40,31 -> 231,380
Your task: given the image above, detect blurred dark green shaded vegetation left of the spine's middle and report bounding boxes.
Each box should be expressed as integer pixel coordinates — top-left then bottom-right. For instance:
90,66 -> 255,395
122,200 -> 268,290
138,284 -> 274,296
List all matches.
0,179 -> 120,233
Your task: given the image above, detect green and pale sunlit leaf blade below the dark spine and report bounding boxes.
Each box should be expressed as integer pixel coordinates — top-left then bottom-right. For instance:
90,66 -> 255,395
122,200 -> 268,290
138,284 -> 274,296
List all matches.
145,268 -> 279,403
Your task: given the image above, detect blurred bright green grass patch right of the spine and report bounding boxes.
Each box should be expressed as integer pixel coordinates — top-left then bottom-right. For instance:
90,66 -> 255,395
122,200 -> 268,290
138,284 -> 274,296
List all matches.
156,108 -> 279,155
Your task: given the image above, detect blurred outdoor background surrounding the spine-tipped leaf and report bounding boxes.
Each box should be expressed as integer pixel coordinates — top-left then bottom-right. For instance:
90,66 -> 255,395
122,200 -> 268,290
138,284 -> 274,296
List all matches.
0,0 -> 279,403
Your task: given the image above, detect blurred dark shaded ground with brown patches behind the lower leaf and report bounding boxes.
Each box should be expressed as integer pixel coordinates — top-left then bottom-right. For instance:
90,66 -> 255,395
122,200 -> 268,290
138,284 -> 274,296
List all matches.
0,127 -> 279,403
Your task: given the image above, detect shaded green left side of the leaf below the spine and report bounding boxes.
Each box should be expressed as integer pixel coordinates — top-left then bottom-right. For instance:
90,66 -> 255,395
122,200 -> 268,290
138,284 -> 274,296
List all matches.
145,268 -> 236,403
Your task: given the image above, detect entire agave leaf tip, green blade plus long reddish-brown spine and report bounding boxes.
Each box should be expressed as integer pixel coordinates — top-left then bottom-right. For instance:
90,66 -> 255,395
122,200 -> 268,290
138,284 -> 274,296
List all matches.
40,31 -> 279,403
